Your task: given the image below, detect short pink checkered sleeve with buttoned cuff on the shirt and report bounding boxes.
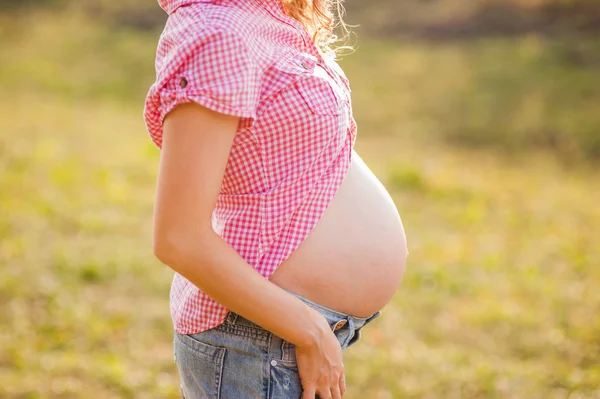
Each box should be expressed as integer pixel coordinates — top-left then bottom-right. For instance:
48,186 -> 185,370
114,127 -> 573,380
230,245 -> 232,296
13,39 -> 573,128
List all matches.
144,27 -> 260,148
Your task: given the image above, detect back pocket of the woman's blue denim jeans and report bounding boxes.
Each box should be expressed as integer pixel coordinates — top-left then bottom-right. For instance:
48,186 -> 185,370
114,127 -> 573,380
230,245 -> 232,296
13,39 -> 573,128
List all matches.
174,333 -> 227,399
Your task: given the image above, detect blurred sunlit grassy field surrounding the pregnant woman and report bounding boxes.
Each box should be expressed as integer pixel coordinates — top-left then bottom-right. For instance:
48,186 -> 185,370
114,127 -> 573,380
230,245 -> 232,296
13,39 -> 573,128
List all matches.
0,0 -> 600,399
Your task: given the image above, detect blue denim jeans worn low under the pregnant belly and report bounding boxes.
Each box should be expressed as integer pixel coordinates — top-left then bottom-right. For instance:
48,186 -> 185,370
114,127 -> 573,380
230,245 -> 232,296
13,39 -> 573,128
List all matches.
173,291 -> 381,399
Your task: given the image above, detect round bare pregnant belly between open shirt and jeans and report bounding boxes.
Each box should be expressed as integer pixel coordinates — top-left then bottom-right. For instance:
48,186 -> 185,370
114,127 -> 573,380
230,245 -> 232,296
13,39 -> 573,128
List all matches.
269,152 -> 407,317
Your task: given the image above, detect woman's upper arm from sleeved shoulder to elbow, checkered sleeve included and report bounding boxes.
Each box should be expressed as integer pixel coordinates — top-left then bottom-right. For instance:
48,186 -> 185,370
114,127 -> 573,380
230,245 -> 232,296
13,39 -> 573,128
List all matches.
144,21 -> 262,252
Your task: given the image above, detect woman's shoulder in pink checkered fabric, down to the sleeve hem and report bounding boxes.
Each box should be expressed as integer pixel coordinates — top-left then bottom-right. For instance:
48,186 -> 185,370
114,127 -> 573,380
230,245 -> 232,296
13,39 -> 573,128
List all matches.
144,2 -> 263,147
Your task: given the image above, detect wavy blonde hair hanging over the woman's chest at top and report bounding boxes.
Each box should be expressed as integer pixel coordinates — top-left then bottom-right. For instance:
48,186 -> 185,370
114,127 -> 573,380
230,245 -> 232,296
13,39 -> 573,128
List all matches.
282,0 -> 352,54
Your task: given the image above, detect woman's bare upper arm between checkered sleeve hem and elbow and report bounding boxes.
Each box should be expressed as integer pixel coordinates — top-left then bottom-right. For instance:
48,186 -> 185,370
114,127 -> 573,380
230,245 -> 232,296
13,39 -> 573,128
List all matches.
154,103 -> 239,251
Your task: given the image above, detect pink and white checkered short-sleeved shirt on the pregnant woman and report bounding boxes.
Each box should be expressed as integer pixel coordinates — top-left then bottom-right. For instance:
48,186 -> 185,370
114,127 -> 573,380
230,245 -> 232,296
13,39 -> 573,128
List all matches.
144,0 -> 356,334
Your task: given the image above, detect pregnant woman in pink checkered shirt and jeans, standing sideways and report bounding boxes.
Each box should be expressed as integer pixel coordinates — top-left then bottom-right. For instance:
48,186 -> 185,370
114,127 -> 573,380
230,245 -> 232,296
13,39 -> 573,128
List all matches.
144,0 -> 407,399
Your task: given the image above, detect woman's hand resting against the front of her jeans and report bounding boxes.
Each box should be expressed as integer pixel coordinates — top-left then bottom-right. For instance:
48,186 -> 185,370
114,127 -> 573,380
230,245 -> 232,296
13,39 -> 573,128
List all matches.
296,308 -> 346,399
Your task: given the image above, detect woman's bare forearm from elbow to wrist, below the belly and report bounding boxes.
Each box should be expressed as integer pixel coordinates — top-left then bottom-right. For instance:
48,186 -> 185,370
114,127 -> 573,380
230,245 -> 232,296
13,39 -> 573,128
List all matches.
155,229 -> 323,345
